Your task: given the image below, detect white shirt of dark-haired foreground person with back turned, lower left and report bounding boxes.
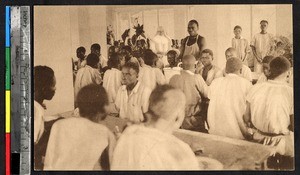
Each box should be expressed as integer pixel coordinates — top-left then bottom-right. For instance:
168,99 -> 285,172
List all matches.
44,117 -> 115,170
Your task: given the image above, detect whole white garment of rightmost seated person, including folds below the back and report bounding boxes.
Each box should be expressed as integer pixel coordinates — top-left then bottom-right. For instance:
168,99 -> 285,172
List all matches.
247,80 -> 294,156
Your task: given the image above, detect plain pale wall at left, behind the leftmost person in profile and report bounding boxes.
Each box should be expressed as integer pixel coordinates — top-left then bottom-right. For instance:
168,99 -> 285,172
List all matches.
34,6 -> 107,115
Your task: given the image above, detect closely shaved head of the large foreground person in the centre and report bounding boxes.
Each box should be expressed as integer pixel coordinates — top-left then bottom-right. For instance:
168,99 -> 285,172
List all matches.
149,85 -> 185,121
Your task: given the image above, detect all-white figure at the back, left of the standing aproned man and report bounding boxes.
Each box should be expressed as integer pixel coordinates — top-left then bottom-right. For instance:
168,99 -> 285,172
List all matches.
150,26 -> 171,66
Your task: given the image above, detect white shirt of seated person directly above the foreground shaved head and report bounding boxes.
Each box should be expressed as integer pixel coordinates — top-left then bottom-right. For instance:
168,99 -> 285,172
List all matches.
138,64 -> 166,90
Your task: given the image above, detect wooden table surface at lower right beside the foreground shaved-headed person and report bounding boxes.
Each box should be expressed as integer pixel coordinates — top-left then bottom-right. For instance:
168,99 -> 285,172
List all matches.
174,129 -> 274,170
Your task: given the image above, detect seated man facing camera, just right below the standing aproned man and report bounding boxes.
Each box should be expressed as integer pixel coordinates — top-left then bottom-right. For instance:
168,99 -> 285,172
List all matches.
196,49 -> 223,86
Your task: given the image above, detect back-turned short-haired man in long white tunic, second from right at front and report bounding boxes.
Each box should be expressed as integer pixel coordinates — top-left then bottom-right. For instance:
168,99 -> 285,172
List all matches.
207,57 -> 251,139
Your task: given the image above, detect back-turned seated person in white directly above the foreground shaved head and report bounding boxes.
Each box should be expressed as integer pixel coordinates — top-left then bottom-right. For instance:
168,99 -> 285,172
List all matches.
139,50 -> 166,90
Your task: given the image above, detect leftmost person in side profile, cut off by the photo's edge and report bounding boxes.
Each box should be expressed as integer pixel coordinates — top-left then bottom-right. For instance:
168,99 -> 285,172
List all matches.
33,66 -> 58,170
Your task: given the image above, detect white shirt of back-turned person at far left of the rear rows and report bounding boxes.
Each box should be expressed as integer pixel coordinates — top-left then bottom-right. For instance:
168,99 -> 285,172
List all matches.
74,65 -> 102,99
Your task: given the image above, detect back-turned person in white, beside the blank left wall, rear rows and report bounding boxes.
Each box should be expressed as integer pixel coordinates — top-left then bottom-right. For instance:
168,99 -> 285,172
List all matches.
74,54 -> 102,102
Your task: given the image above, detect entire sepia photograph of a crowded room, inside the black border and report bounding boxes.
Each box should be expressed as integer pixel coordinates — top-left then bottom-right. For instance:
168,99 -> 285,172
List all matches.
32,4 -> 295,171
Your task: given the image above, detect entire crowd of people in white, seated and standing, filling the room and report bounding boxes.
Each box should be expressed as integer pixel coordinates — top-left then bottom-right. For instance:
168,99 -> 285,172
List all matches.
34,20 -> 294,170
